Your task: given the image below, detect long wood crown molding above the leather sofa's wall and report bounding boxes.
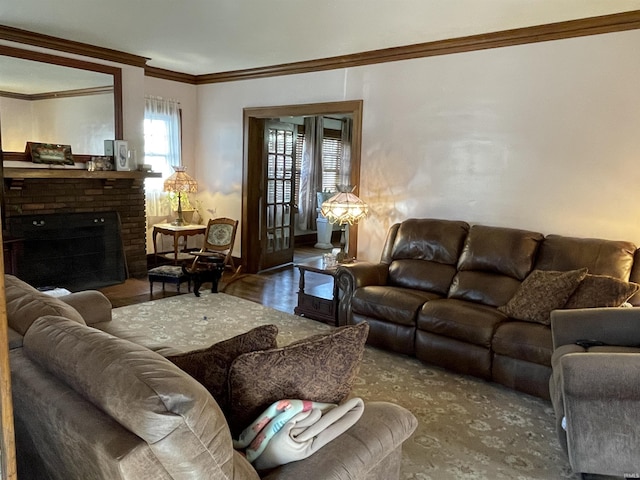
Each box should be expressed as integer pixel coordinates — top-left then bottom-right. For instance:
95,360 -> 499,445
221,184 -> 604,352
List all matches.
196,10 -> 640,85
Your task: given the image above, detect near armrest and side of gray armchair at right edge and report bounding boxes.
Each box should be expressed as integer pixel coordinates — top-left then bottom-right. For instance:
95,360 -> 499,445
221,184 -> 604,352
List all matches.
554,352 -> 640,478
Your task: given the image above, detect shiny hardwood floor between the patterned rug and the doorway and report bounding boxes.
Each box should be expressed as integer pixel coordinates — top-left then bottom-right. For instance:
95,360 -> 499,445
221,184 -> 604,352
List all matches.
100,247 -> 331,313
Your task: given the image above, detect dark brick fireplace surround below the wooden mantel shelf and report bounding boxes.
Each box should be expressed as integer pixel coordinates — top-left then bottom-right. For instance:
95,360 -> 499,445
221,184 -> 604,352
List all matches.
4,177 -> 147,284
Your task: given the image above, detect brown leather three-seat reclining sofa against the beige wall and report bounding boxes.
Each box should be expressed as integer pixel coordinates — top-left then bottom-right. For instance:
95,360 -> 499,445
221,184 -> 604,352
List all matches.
336,219 -> 640,399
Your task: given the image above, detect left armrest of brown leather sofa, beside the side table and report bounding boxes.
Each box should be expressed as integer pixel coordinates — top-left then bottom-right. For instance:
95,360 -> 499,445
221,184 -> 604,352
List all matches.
335,262 -> 389,325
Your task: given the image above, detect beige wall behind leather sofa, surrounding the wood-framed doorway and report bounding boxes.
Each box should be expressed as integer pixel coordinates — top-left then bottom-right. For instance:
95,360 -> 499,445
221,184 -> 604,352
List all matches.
188,31 -> 640,260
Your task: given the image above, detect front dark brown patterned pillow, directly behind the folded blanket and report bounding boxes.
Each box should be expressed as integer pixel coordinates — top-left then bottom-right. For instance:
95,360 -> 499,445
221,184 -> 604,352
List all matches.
227,323 -> 369,436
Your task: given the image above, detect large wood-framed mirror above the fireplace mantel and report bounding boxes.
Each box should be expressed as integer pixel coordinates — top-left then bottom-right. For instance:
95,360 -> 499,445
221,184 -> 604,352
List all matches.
0,45 -> 122,162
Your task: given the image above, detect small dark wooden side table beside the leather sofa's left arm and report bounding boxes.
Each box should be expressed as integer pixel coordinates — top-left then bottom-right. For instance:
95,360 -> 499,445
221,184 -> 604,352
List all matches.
294,259 -> 338,326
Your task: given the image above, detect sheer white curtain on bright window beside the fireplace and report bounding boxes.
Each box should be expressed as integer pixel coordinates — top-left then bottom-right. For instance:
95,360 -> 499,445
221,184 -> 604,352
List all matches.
144,96 -> 182,217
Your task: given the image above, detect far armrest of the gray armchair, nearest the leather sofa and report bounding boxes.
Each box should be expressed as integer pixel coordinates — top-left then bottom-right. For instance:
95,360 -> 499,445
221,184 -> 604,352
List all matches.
551,307 -> 640,349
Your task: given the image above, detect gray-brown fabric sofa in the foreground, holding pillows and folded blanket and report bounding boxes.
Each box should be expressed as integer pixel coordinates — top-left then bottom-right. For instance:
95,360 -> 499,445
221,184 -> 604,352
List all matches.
5,275 -> 416,480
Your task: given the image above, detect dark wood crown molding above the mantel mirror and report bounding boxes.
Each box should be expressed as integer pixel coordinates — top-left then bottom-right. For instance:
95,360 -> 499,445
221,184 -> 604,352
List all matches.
0,25 -> 149,68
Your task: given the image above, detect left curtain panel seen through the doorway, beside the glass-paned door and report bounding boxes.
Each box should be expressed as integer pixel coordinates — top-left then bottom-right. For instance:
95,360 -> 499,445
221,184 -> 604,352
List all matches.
298,117 -> 324,230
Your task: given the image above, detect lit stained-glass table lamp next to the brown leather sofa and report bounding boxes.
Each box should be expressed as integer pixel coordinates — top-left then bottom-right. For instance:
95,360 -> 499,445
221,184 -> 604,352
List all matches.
320,185 -> 369,263
